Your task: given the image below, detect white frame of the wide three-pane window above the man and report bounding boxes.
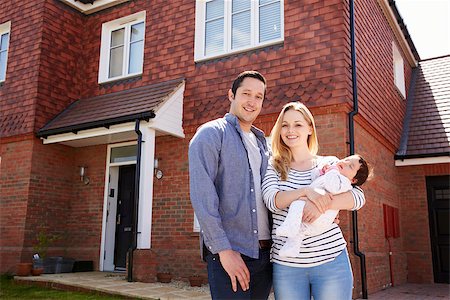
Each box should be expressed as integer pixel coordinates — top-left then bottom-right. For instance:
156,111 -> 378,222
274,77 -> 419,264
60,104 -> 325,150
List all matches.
194,0 -> 284,62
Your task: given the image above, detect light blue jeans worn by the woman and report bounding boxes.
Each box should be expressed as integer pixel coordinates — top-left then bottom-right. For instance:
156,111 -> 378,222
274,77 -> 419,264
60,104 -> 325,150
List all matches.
273,249 -> 353,300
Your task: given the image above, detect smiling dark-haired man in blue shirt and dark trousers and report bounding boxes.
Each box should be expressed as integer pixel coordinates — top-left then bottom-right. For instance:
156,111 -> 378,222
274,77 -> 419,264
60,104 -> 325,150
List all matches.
189,71 -> 272,299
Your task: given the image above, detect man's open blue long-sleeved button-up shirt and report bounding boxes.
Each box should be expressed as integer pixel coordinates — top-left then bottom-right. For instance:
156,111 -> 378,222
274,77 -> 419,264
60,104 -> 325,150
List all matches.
189,113 -> 269,258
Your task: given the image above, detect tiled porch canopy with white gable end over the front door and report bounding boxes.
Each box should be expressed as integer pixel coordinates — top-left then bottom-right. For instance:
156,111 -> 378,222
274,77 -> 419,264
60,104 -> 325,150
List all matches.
37,79 -> 184,147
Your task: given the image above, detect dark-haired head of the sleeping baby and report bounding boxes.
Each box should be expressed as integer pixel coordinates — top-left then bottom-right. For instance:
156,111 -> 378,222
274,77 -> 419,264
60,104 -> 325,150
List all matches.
336,154 -> 370,186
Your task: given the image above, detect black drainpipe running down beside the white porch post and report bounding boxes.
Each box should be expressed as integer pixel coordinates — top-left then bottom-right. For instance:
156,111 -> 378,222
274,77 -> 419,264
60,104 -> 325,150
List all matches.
127,119 -> 142,282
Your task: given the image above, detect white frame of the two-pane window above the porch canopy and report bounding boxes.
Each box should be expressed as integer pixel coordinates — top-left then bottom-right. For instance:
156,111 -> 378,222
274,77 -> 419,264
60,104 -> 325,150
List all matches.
98,11 -> 145,83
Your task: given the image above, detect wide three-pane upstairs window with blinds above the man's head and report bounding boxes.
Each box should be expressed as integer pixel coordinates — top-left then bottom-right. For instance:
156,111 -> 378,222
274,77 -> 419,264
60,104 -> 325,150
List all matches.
195,0 -> 284,61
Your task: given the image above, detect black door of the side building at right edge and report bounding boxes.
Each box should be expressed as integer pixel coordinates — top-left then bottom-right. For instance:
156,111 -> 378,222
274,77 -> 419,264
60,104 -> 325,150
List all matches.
427,176 -> 450,283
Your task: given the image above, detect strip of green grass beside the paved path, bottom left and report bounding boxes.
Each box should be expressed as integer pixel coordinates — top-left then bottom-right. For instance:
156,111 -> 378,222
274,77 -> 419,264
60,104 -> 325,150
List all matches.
0,275 -> 134,300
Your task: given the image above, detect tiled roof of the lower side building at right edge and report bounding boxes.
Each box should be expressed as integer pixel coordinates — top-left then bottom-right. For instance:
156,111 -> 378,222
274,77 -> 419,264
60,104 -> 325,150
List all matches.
395,55 -> 450,166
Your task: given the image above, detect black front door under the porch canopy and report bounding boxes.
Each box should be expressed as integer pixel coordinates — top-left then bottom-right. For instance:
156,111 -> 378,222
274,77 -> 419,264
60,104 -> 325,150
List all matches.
114,165 -> 136,269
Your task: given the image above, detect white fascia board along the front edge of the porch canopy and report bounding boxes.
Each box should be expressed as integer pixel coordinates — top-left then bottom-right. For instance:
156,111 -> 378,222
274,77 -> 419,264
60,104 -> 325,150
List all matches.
42,122 -> 135,144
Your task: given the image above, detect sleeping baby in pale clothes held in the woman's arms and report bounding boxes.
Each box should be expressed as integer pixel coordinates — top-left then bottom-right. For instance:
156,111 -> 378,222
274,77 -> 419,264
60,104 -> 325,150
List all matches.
276,155 -> 369,257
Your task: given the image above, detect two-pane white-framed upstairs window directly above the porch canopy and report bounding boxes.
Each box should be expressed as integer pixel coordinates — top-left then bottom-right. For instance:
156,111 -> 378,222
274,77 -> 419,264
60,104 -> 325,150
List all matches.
98,11 -> 145,83
